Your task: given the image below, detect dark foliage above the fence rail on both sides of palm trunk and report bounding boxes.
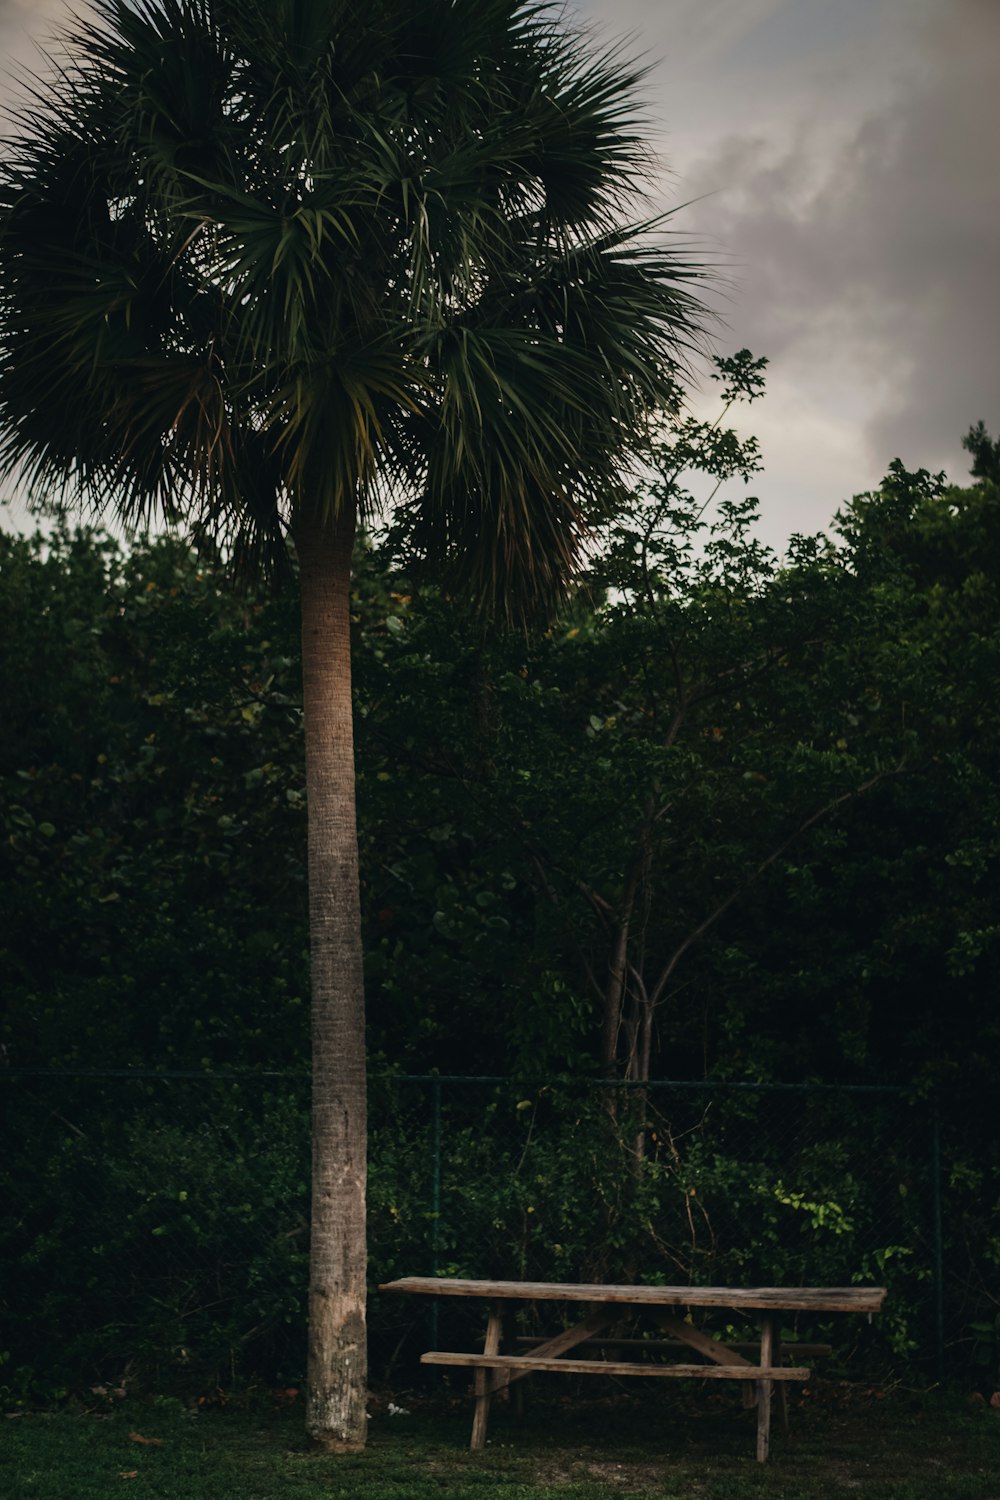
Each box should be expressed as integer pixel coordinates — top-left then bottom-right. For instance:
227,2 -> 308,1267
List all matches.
7,393 -> 1000,1089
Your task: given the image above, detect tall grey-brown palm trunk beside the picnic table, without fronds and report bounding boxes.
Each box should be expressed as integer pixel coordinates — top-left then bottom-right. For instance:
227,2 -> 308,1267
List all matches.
294,504 -> 367,1452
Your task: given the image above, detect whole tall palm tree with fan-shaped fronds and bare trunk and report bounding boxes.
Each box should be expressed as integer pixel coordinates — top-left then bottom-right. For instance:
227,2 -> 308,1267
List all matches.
0,0 -> 700,1449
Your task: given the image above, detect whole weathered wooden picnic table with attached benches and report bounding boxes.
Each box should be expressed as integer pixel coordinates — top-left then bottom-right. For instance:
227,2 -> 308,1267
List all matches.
379,1277 -> 886,1463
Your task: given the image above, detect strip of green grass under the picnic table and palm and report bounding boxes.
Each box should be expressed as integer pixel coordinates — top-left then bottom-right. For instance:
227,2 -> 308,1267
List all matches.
0,1382 -> 1000,1500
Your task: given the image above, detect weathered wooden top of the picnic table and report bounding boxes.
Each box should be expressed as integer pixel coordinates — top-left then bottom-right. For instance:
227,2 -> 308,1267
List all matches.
378,1277 -> 886,1313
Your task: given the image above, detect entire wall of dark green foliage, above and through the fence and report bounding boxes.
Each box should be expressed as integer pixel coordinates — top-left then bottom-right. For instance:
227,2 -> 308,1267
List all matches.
0,396 -> 1000,1388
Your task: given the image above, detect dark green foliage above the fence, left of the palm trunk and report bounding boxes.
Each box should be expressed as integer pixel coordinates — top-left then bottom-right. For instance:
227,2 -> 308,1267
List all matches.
0,524 -> 309,1071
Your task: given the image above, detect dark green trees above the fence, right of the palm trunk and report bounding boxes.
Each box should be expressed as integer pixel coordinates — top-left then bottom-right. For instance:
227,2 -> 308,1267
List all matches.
358,387 -> 997,1100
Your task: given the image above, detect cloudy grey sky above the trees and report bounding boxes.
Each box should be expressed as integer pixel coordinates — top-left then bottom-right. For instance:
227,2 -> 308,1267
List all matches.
0,0 -> 1000,543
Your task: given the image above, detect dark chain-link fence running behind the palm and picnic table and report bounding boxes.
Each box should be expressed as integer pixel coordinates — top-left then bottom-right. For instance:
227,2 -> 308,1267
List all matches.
0,1073 -> 1000,1395
